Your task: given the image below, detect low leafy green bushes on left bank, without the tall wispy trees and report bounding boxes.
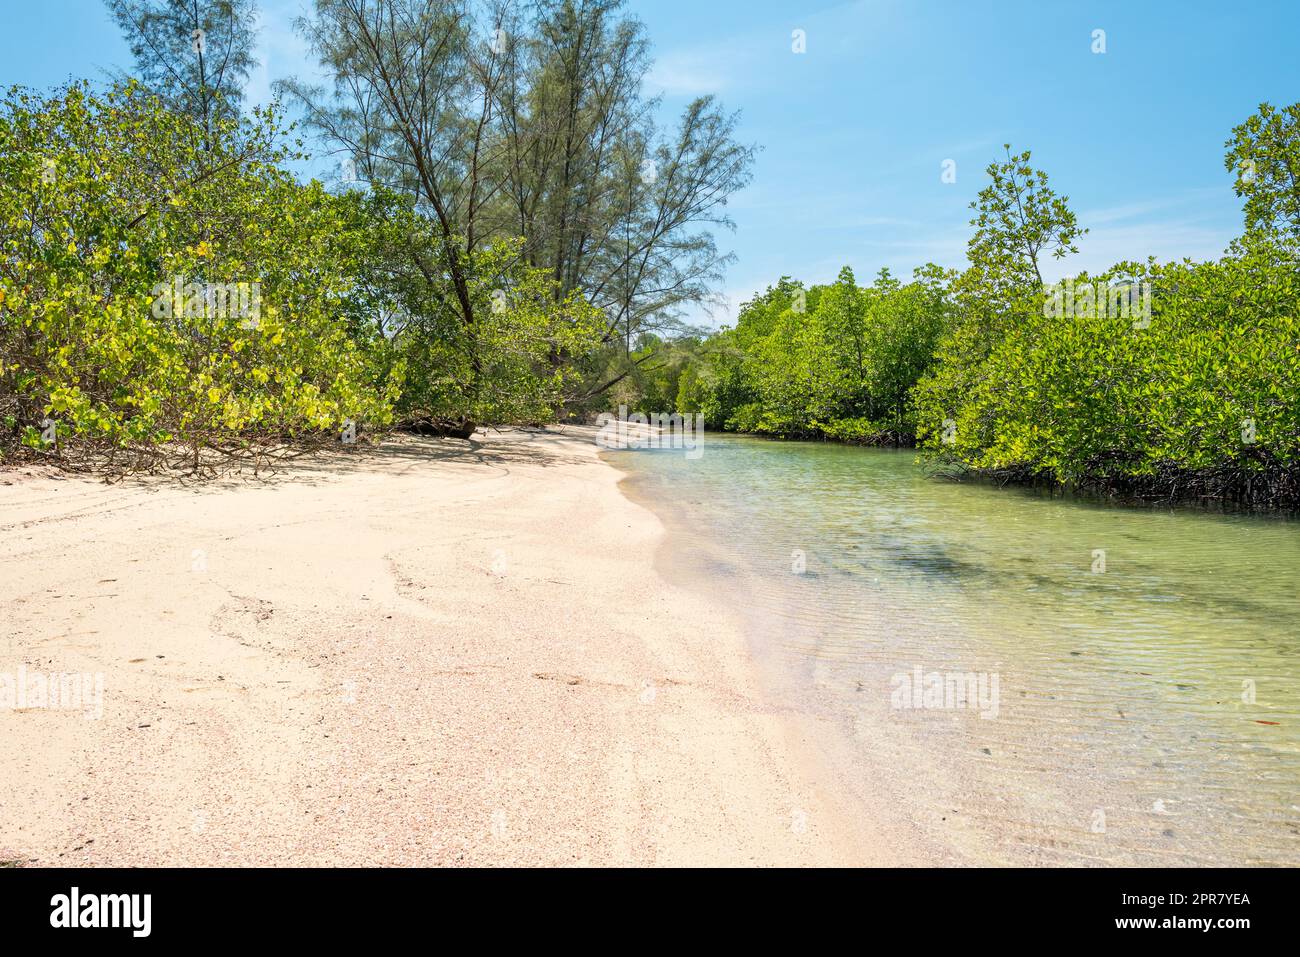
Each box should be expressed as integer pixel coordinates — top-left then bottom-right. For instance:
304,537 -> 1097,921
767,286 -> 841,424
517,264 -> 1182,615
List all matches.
0,82 -> 601,469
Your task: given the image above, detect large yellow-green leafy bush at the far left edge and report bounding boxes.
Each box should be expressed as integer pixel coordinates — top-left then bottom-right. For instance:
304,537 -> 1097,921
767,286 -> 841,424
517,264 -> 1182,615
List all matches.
0,83 -> 400,465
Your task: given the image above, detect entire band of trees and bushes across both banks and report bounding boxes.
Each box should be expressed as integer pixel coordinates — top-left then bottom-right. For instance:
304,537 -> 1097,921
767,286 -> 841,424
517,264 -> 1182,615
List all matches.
0,0 -> 1300,502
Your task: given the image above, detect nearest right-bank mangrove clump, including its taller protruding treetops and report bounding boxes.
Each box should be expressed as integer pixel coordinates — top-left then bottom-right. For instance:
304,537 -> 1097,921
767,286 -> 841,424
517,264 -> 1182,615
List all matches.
913,111 -> 1300,503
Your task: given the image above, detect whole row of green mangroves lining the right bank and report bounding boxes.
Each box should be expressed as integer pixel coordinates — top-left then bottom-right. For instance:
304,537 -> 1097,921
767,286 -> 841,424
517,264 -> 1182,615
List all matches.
650,111 -> 1300,503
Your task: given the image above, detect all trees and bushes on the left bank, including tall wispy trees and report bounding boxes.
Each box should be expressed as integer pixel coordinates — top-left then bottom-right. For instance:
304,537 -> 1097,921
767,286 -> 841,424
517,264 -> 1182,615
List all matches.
0,0 -> 753,471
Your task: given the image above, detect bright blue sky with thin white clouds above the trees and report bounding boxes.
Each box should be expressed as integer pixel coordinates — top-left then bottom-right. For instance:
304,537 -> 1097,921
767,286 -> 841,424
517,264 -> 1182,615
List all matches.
0,0 -> 1300,328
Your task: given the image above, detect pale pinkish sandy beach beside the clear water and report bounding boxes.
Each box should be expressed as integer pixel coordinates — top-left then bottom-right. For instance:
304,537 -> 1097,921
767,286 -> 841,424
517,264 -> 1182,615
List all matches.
0,428 -> 904,866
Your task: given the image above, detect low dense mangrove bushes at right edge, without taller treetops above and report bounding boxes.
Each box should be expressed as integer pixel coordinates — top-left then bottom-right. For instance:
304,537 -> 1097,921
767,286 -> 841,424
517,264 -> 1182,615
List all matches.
918,234 -> 1300,501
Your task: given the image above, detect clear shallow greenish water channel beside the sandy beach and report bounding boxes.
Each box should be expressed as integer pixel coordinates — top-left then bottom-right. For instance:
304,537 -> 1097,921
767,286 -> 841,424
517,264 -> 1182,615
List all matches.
607,436 -> 1300,865
